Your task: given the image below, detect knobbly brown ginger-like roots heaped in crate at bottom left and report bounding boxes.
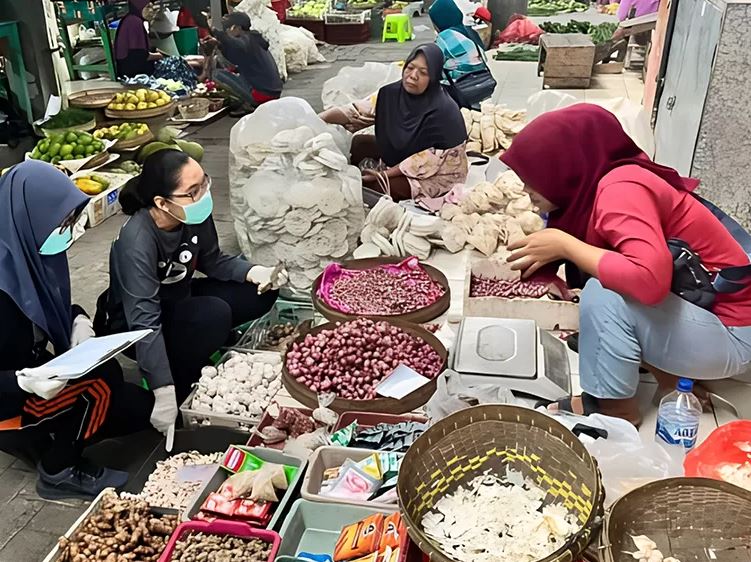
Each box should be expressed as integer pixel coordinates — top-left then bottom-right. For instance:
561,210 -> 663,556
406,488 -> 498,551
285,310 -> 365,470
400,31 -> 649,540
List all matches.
58,492 -> 177,562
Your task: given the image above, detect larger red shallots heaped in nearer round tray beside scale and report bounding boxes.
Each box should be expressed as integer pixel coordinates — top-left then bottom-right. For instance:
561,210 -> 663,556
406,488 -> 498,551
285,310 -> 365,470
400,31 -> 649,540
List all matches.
286,318 -> 443,400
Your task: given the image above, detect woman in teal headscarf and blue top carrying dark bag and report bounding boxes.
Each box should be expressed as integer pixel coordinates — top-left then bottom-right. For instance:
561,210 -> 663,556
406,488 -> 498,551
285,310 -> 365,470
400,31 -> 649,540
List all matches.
428,0 -> 486,80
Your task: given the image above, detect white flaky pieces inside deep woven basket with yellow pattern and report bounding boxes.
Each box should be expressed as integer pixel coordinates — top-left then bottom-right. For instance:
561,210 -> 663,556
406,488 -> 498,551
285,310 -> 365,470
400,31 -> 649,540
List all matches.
421,468 -> 581,562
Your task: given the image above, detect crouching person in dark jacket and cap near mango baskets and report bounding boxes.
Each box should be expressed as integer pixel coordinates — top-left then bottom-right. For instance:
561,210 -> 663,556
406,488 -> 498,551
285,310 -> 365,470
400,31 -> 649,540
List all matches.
204,11 -> 282,115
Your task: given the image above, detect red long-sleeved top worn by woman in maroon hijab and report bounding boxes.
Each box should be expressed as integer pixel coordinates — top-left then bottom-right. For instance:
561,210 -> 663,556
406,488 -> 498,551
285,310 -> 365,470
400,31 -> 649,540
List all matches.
586,165 -> 751,326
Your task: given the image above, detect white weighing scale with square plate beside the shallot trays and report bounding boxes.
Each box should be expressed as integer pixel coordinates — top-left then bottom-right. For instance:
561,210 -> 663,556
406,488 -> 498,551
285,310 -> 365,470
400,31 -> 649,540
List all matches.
454,317 -> 571,400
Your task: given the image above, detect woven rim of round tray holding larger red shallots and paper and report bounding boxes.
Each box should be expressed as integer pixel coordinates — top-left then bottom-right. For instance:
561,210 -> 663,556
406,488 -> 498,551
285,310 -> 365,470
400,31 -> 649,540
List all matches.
282,320 -> 448,414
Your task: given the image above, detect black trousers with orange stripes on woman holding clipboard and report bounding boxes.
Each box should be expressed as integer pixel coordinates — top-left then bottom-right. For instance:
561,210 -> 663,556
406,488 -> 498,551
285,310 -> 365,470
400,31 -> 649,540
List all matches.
0,360 -> 154,473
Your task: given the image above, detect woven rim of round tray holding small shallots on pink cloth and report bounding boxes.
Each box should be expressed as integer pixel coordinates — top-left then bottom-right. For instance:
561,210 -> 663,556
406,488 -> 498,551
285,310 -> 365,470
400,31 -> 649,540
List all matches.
312,257 -> 451,324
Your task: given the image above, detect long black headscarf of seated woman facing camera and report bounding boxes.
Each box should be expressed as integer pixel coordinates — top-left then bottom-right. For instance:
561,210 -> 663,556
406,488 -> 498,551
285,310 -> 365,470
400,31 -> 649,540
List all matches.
375,43 -> 467,166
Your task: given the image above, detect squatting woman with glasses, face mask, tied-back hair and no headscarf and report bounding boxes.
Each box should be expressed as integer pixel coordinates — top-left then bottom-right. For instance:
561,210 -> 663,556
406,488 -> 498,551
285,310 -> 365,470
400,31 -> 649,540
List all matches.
95,150 -> 286,434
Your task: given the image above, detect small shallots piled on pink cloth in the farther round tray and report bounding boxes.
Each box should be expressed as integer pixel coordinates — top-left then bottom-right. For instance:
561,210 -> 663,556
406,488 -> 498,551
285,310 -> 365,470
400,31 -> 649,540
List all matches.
328,267 -> 446,316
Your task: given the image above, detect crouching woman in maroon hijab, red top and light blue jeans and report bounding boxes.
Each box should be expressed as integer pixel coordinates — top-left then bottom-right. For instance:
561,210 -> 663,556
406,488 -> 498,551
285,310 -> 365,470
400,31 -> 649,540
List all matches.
501,104 -> 751,424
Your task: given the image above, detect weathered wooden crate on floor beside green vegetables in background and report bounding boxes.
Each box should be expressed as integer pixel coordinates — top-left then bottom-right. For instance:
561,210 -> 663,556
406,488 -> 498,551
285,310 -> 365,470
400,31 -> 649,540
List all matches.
537,33 -> 595,88
